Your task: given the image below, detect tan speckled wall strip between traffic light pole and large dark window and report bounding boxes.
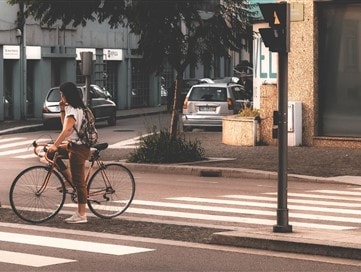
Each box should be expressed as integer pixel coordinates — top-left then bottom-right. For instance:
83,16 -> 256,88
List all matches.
288,0 -> 318,146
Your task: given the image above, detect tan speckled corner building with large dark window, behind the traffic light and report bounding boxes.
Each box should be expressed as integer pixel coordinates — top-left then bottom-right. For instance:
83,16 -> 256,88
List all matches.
253,0 -> 361,147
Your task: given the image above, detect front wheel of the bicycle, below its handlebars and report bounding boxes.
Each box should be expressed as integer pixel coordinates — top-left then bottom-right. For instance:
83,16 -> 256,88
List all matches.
9,166 -> 65,223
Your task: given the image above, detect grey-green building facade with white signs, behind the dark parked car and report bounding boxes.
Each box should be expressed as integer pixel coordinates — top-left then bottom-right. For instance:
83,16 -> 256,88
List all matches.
0,0 -> 243,121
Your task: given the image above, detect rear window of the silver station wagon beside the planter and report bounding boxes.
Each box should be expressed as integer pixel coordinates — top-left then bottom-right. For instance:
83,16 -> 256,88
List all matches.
188,87 -> 227,102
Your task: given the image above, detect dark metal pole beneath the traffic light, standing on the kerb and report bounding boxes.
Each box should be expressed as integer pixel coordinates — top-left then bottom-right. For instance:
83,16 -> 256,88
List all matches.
273,52 -> 292,232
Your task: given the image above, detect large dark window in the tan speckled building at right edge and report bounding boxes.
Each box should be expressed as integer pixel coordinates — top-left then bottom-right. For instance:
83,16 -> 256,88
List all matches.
318,1 -> 361,137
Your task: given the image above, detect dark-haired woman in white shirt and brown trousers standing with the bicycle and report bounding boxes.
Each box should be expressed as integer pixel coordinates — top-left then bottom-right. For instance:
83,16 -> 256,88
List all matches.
48,82 -> 90,223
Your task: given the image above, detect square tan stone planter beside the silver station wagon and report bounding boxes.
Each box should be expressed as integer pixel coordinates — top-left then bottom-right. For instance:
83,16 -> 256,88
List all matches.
222,115 -> 259,146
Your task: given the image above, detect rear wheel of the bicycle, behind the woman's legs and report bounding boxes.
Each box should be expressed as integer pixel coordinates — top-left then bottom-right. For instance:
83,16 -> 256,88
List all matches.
88,163 -> 135,218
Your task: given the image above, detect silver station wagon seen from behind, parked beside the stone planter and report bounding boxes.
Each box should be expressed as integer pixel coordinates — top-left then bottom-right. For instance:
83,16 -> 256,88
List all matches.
182,83 -> 249,131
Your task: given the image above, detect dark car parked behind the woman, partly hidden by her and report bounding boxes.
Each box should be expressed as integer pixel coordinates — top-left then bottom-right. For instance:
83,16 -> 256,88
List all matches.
43,85 -> 116,127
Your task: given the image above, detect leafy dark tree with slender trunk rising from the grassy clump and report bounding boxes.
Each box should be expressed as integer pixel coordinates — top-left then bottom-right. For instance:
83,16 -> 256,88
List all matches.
10,0 -> 251,136
